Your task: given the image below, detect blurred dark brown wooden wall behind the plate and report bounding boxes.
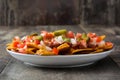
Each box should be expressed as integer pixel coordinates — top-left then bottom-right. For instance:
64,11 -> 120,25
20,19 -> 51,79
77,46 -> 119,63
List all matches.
0,0 -> 120,26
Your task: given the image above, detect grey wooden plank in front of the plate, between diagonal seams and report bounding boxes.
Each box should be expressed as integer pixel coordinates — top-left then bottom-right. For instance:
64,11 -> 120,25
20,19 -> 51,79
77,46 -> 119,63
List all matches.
0,57 -> 120,80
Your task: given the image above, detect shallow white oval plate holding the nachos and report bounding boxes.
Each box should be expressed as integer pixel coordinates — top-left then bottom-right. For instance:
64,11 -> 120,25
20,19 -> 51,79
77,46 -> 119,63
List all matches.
7,49 -> 113,67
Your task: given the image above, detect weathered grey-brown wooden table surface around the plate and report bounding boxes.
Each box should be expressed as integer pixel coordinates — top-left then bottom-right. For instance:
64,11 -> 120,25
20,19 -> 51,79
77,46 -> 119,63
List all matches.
0,25 -> 120,80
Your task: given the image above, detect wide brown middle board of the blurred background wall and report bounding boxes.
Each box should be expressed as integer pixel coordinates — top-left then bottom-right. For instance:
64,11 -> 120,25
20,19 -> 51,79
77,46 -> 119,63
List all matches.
8,0 -> 79,25
